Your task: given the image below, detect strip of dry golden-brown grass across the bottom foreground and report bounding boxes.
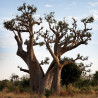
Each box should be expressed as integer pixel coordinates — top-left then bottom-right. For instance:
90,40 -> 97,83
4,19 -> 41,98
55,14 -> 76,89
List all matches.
0,85 -> 98,98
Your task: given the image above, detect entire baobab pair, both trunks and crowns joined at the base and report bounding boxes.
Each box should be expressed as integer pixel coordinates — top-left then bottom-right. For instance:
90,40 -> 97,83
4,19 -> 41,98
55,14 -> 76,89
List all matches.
4,4 -> 94,94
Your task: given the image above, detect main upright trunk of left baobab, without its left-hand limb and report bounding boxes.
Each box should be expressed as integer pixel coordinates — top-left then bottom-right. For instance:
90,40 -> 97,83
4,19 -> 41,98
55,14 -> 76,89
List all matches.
27,35 -> 44,92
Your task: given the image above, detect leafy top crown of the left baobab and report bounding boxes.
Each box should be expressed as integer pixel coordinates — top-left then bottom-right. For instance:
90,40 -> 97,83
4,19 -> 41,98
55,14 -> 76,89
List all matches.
4,3 -> 38,32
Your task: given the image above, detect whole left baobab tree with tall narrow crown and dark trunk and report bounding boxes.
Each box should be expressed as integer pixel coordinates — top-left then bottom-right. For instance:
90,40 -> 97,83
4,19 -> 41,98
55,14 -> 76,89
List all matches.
4,4 -> 44,92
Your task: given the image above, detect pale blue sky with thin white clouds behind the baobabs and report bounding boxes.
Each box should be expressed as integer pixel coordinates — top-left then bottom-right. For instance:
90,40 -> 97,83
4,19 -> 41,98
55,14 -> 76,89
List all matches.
0,0 -> 98,80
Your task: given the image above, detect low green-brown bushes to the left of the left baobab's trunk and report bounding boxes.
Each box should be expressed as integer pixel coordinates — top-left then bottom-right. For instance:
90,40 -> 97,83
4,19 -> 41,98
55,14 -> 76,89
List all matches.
0,74 -> 30,93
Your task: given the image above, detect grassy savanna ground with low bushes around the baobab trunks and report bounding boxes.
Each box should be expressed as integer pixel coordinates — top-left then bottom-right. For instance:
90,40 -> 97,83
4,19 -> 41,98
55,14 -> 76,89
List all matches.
0,72 -> 98,98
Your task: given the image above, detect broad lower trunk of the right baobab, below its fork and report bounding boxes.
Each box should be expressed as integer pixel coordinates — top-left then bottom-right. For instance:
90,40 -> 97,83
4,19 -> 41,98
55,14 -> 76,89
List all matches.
40,61 -> 61,94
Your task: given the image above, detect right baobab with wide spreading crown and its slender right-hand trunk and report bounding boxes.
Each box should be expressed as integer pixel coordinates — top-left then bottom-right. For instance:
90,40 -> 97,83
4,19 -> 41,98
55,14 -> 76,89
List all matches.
40,12 -> 94,93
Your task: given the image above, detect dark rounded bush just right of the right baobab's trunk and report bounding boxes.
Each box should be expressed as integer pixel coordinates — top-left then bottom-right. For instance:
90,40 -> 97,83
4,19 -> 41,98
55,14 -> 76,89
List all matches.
61,63 -> 81,85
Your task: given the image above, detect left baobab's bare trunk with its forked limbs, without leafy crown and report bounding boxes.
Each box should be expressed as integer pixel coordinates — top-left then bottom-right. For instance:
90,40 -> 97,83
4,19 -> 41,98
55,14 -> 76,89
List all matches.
15,35 -> 44,92
